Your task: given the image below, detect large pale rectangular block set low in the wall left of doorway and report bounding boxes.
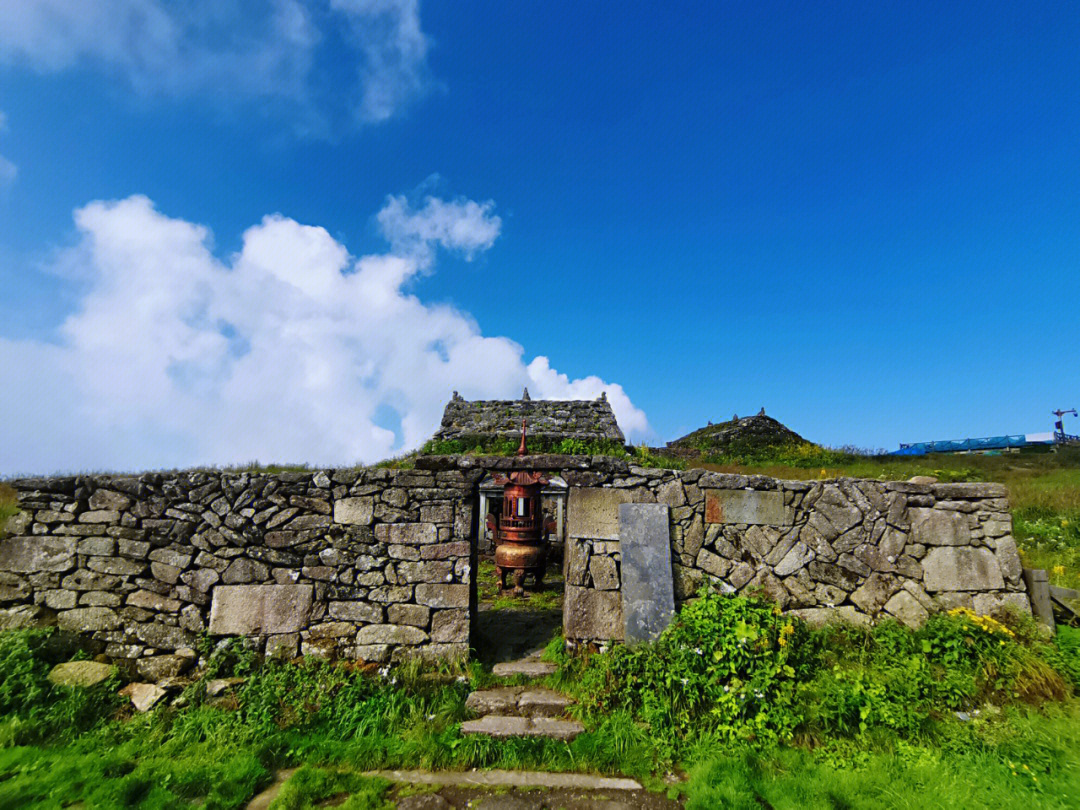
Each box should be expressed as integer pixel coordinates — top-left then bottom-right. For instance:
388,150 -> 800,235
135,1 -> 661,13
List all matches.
210,585 -> 312,635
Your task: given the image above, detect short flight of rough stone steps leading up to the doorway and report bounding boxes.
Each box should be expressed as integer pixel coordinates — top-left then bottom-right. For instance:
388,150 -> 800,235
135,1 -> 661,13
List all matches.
461,653 -> 585,742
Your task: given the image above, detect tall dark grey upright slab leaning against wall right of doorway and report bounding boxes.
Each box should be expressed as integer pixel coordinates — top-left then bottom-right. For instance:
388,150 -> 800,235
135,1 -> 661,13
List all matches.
619,503 -> 675,644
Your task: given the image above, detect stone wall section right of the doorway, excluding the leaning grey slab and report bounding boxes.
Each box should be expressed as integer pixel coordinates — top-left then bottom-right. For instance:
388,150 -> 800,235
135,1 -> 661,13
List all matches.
564,467 -> 1030,640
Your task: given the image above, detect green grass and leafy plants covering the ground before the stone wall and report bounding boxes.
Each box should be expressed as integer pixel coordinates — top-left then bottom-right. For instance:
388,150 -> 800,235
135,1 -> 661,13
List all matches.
0,593 -> 1080,810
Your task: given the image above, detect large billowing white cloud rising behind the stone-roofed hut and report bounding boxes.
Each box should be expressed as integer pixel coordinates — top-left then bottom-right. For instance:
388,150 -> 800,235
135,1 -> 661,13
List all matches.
0,197 -> 648,474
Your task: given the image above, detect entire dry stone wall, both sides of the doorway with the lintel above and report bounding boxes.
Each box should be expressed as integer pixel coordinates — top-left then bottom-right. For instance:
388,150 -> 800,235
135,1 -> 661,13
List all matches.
0,455 -> 1030,679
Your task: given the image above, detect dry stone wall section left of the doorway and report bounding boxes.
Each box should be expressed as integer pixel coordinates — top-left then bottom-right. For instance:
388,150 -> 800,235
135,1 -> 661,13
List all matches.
0,469 -> 482,675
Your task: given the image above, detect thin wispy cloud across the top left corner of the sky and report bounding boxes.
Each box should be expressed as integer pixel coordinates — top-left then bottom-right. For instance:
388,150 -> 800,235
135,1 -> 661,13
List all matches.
0,0 -> 430,122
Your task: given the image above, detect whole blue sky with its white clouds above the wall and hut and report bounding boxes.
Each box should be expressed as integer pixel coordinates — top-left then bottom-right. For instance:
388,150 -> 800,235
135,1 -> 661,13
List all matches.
0,0 -> 1080,474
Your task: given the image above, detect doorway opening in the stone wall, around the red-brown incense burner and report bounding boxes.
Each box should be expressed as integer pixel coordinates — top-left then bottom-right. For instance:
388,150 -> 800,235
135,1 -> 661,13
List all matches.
473,476 -> 567,664
